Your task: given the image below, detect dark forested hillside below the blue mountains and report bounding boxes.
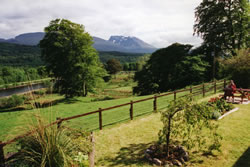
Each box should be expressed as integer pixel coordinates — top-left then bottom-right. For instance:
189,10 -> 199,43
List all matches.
0,42 -> 144,66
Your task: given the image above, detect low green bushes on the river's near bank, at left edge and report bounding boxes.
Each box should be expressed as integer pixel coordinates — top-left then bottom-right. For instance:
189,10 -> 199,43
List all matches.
0,95 -> 25,108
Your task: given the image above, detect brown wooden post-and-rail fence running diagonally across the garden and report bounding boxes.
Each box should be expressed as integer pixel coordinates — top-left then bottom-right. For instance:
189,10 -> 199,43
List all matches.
0,80 -> 227,167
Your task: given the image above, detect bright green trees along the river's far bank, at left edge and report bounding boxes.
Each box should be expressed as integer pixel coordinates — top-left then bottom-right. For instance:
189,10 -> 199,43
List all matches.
0,66 -> 47,85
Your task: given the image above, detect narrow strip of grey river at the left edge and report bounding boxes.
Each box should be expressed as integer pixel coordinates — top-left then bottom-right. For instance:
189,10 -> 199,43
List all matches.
0,83 -> 46,97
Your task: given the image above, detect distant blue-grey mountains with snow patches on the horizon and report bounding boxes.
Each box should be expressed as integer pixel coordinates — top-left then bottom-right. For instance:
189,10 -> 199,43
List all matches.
0,32 -> 157,53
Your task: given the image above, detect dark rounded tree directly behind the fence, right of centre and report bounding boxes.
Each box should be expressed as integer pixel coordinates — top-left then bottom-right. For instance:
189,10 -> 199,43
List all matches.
133,43 -> 208,95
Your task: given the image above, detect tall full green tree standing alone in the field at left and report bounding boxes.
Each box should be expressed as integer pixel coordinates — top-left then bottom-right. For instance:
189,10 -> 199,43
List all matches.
39,19 -> 105,97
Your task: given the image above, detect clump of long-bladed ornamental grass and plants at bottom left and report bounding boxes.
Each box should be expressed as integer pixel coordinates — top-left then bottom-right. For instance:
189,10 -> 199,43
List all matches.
8,116 -> 91,167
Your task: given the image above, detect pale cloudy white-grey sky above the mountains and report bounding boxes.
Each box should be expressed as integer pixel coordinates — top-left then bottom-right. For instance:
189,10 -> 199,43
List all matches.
0,0 -> 202,48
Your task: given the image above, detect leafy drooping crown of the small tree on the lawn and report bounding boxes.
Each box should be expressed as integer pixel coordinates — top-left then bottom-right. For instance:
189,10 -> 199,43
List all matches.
159,97 -> 221,157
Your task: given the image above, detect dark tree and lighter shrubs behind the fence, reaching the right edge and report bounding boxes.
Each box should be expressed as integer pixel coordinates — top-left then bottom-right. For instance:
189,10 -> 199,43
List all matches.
133,43 -> 250,95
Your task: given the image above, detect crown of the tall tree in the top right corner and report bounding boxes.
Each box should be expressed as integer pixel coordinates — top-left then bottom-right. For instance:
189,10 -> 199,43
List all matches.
194,0 -> 249,56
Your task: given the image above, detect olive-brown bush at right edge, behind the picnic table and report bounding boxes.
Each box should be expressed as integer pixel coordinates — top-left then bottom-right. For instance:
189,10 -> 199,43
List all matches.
220,48 -> 250,88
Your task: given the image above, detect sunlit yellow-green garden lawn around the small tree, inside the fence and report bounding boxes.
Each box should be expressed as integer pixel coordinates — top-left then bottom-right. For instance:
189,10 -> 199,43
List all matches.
95,102 -> 250,167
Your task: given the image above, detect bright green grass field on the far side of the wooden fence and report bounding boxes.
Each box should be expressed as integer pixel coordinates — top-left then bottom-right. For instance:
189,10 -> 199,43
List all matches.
0,80 -> 221,141
